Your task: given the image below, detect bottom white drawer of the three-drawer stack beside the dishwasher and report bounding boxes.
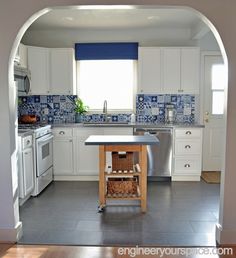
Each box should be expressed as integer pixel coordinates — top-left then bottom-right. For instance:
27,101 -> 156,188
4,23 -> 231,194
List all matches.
174,156 -> 201,175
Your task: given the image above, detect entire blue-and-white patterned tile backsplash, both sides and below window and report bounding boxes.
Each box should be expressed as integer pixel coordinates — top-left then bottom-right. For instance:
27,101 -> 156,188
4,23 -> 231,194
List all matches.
18,94 -> 196,123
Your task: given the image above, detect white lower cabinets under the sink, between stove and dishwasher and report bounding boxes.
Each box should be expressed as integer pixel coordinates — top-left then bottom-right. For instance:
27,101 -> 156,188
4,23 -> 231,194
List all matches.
53,126 -> 133,180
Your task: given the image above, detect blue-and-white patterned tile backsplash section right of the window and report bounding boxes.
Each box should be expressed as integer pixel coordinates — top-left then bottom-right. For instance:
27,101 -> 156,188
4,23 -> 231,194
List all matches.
136,94 -> 195,123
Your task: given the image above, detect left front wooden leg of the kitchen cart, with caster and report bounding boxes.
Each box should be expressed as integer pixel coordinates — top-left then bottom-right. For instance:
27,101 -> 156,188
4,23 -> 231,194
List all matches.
98,145 -> 106,212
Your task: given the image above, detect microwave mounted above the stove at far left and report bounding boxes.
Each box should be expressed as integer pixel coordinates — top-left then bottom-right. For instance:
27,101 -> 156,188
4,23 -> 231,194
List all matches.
14,65 -> 31,96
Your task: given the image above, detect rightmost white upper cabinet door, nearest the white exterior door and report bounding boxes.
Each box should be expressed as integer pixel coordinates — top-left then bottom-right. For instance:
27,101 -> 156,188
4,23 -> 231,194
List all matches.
181,48 -> 200,94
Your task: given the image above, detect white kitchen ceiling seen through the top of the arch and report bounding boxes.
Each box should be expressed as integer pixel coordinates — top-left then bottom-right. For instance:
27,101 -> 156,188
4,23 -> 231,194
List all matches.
29,8 -> 201,30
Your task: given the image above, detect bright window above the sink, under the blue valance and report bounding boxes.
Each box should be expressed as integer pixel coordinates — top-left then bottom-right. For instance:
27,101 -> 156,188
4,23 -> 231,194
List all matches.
77,60 -> 137,111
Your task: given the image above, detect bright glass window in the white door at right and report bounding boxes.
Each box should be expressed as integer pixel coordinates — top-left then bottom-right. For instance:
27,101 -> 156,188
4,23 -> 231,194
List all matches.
211,64 -> 227,115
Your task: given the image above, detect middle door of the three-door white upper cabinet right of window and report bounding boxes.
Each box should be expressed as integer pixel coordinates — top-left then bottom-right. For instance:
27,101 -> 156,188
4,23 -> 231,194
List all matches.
162,48 -> 181,94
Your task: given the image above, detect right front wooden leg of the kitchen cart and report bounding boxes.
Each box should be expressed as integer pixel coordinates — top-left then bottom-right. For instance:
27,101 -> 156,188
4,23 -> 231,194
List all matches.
139,145 -> 147,212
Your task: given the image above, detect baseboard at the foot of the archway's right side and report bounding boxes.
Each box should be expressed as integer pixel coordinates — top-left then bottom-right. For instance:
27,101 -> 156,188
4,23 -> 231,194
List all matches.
216,224 -> 236,245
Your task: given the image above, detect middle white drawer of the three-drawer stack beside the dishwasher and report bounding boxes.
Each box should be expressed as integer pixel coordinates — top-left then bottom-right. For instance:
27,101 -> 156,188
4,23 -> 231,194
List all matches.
175,140 -> 201,155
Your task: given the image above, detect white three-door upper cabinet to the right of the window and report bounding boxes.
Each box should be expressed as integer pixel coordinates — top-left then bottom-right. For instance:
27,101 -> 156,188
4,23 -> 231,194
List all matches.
138,47 -> 200,94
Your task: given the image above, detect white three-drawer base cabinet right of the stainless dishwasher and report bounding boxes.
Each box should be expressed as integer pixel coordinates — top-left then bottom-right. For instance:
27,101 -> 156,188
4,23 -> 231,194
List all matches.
172,128 -> 202,181
